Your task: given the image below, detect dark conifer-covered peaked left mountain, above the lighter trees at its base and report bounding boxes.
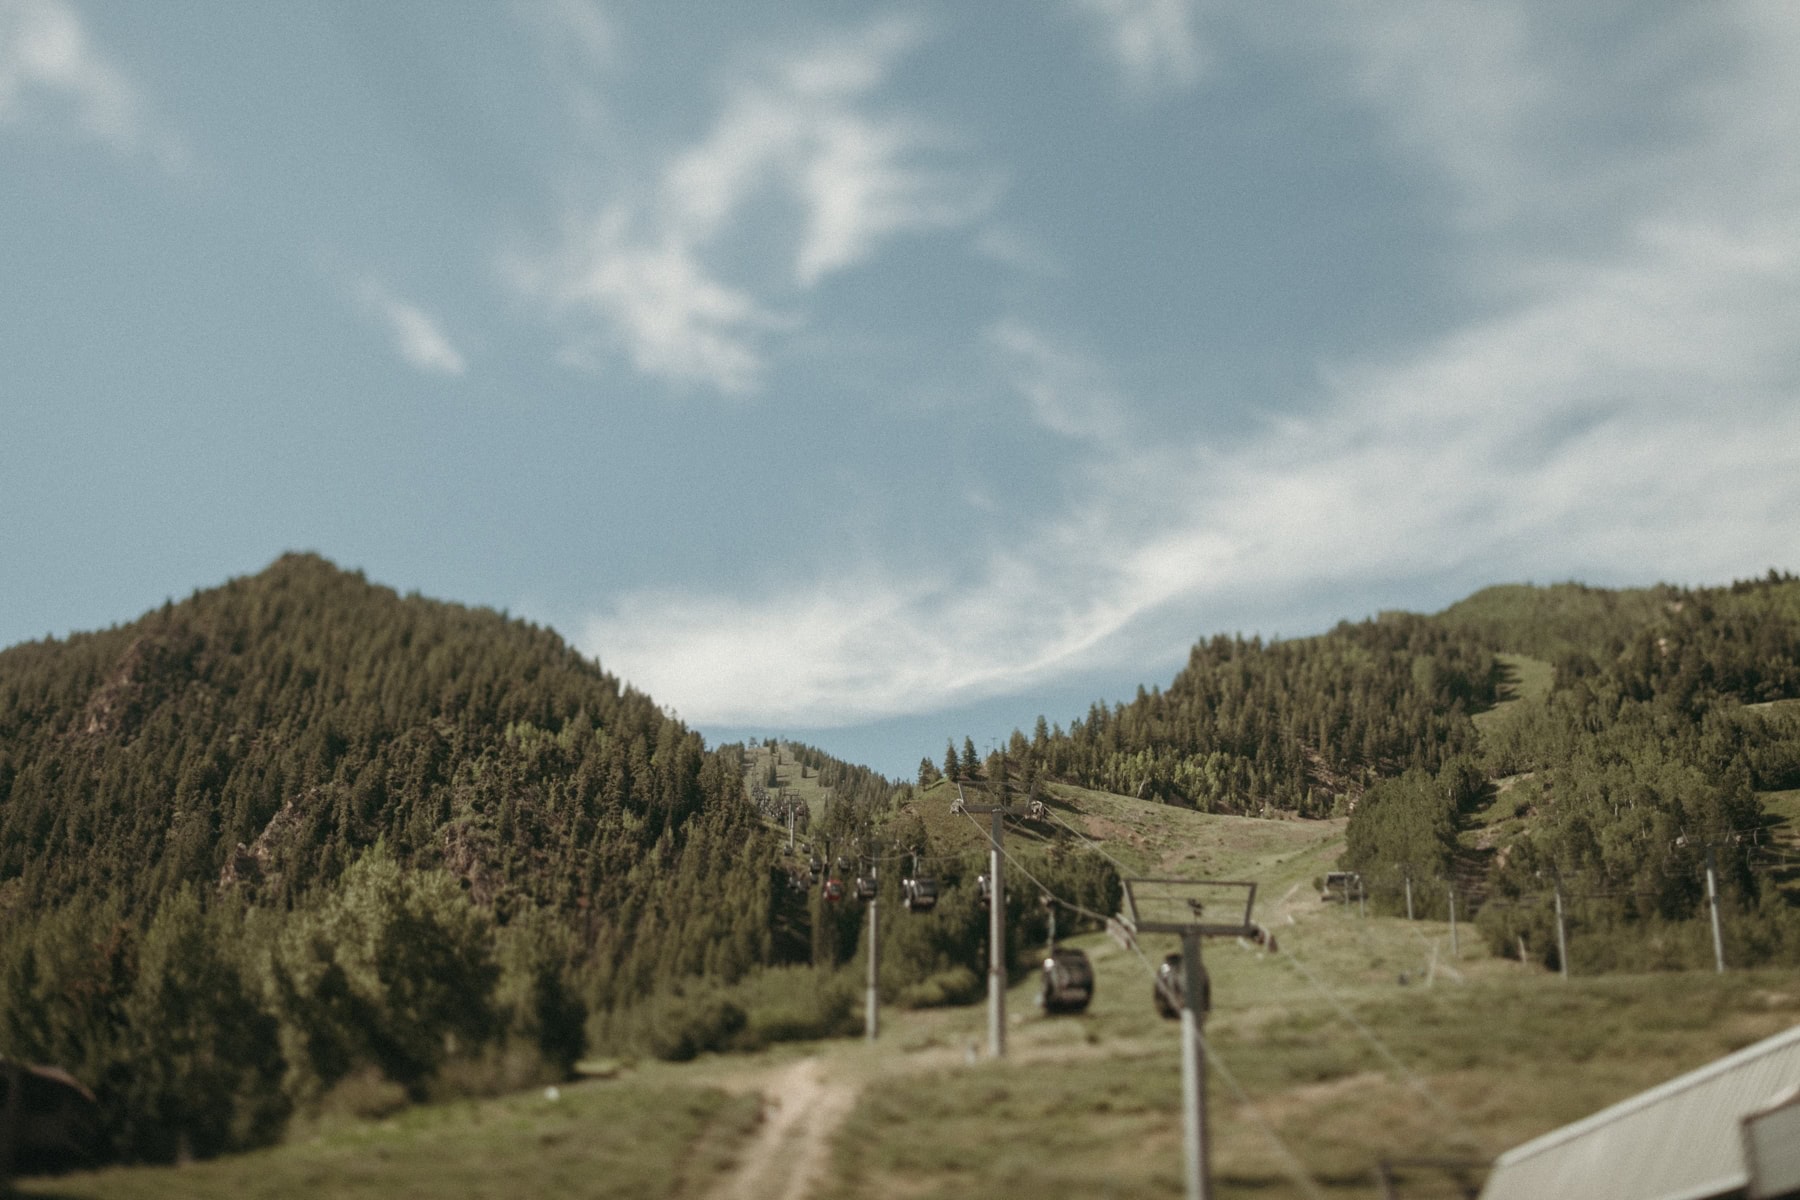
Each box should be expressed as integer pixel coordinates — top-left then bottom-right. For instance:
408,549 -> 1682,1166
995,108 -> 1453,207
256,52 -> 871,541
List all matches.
0,554 -> 766,935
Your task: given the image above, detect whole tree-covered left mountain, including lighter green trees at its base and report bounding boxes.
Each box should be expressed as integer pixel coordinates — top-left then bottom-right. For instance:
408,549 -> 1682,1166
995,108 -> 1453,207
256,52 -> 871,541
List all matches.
0,556 -> 788,1157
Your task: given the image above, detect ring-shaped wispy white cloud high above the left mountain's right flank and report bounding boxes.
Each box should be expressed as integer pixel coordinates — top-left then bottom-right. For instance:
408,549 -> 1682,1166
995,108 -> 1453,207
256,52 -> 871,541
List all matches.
511,22 -> 994,394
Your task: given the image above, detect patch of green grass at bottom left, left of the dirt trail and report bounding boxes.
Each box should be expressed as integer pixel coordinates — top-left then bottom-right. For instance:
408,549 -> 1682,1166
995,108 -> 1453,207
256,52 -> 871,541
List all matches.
18,1076 -> 758,1200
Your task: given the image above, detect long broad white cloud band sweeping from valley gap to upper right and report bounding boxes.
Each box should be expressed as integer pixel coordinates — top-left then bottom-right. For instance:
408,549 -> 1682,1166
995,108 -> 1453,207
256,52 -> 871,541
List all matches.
583,5 -> 1800,727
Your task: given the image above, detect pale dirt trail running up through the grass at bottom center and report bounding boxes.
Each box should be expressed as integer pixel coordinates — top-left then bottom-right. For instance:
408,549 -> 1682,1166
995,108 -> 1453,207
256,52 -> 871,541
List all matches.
707,1058 -> 857,1200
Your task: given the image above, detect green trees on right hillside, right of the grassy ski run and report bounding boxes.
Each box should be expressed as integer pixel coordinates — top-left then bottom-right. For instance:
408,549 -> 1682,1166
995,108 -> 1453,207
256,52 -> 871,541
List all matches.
1345,572 -> 1800,966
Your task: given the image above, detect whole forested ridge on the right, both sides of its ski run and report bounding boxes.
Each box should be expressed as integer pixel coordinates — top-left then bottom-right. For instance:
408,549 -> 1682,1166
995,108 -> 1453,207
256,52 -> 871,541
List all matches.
920,570 -> 1800,968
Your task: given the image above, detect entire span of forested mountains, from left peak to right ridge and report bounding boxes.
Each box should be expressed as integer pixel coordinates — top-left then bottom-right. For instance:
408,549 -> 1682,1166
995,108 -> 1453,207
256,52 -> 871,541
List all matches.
0,556 -> 1800,1180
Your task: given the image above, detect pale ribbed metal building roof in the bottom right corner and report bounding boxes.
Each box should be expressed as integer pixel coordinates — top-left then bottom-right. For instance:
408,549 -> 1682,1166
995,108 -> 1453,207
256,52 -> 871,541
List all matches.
1481,1025 -> 1800,1200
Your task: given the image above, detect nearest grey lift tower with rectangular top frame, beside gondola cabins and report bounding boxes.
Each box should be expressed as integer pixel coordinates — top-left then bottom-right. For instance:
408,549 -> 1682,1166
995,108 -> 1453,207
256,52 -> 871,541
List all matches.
1123,880 -> 1267,1200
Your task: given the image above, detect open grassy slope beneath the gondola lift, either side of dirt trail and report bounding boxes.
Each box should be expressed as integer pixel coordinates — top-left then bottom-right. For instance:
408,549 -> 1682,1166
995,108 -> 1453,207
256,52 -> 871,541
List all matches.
27,788 -> 1800,1200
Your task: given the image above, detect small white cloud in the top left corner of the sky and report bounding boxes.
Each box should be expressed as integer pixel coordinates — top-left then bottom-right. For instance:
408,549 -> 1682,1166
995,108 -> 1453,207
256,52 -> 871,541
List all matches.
0,0 -> 187,171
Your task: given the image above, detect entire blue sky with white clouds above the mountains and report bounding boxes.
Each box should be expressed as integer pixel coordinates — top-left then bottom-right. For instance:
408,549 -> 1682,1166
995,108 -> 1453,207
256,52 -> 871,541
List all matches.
0,0 -> 1800,777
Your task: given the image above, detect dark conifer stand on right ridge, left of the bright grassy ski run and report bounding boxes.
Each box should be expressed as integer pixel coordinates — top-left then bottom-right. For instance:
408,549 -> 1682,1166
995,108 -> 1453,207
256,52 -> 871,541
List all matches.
920,613 -> 1498,817
